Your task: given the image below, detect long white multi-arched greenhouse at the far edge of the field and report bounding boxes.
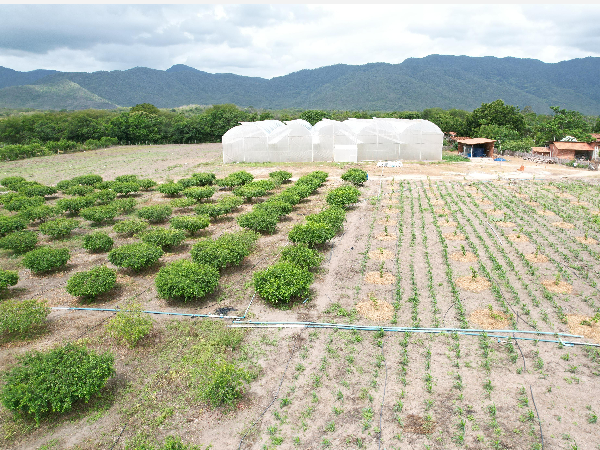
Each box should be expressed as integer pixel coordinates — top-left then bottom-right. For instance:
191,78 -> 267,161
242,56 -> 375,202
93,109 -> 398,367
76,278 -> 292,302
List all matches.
223,118 -> 444,163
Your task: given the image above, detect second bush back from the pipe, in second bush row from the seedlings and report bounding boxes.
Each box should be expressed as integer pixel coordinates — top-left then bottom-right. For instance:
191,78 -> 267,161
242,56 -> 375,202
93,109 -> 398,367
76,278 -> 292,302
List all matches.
191,231 -> 259,269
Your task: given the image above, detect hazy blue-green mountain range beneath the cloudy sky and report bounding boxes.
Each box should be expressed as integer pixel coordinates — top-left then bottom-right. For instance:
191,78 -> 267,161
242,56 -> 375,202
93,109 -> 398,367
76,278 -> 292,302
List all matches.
0,55 -> 600,115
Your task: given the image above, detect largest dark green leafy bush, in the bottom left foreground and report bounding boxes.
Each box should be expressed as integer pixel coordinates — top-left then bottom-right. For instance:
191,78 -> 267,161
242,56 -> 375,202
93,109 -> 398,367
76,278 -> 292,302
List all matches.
0,344 -> 115,423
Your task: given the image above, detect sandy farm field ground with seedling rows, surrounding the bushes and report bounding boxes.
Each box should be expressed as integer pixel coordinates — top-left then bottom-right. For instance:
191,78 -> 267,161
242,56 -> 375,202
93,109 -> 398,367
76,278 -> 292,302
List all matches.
0,144 -> 600,450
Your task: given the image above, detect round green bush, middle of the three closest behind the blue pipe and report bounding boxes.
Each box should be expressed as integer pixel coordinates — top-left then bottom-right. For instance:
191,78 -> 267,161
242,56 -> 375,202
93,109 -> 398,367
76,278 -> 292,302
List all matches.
156,259 -> 219,301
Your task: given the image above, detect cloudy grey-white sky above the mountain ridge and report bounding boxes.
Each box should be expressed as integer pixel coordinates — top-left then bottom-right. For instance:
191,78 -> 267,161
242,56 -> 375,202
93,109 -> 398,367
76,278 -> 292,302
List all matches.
0,4 -> 600,78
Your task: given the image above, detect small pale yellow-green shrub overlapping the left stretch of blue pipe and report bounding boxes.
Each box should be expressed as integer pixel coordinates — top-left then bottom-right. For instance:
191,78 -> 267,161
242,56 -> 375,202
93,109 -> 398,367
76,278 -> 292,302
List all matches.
106,302 -> 154,348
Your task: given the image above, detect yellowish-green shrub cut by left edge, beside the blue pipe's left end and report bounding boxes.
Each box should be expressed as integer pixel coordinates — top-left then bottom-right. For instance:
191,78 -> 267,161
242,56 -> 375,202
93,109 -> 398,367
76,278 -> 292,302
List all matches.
0,298 -> 50,335
